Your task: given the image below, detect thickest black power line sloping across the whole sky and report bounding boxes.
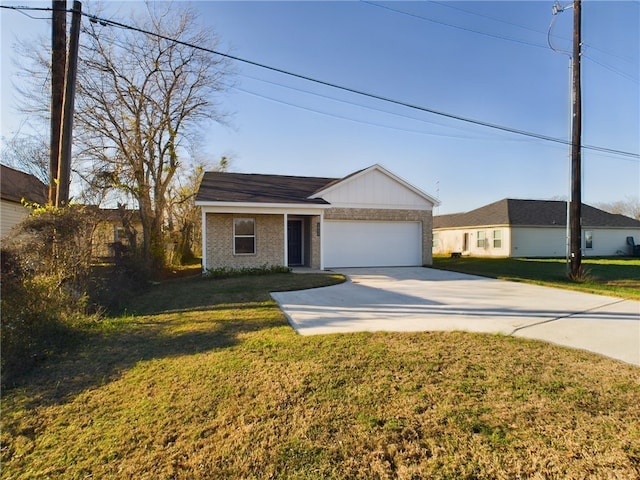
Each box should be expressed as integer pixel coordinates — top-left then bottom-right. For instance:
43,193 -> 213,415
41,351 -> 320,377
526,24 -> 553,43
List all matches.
0,2 -> 640,158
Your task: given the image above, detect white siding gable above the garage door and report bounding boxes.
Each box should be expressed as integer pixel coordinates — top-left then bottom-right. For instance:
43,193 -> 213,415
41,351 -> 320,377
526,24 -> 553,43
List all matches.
317,165 -> 437,210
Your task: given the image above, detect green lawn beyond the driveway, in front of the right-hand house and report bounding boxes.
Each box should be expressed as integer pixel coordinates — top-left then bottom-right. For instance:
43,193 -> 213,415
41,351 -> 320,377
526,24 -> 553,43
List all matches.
433,257 -> 640,300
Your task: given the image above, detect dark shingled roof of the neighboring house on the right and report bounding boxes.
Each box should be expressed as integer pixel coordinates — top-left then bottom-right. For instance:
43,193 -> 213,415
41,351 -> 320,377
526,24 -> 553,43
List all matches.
433,198 -> 640,229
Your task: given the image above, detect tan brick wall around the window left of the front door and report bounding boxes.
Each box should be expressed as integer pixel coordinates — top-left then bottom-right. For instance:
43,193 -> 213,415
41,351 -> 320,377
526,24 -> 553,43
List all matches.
205,213 -> 284,268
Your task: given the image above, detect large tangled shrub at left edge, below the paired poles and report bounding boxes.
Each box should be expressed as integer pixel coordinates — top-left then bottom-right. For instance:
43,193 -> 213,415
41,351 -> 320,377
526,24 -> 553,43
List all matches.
0,206 -> 96,383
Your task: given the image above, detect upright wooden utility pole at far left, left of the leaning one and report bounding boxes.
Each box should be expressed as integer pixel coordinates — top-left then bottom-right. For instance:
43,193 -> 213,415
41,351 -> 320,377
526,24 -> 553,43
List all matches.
49,0 -> 67,205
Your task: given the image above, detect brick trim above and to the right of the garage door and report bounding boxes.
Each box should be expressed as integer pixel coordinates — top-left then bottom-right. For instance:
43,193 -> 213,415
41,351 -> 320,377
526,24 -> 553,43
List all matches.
324,208 -> 433,265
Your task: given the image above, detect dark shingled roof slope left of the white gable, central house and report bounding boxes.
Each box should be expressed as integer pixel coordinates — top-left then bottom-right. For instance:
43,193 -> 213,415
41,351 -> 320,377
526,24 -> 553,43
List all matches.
196,172 -> 339,205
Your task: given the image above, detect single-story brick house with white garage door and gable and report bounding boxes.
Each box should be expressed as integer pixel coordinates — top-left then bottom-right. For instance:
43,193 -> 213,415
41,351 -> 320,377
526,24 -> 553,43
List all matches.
196,165 -> 438,269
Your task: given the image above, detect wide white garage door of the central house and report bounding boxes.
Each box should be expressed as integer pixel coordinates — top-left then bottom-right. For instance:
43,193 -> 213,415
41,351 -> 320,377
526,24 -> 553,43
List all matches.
323,221 -> 422,268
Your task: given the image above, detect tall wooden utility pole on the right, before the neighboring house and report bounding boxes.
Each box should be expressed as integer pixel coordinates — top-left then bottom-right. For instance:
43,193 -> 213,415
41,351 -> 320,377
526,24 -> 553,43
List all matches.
569,0 -> 582,280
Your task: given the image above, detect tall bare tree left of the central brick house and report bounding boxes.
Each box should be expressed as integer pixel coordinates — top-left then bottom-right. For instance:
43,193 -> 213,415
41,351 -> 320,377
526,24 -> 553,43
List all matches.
76,3 -> 229,267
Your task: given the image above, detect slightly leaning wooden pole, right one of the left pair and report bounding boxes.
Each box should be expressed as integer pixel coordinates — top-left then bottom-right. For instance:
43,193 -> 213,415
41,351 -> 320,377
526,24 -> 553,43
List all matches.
56,0 -> 82,207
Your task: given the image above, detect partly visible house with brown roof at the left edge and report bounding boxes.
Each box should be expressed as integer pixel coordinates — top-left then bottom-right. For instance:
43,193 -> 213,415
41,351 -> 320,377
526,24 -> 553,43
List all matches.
0,165 -> 47,238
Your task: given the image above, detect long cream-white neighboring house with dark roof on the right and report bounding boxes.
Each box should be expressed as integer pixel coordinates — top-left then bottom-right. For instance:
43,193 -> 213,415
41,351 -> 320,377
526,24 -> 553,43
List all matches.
433,199 -> 640,257
